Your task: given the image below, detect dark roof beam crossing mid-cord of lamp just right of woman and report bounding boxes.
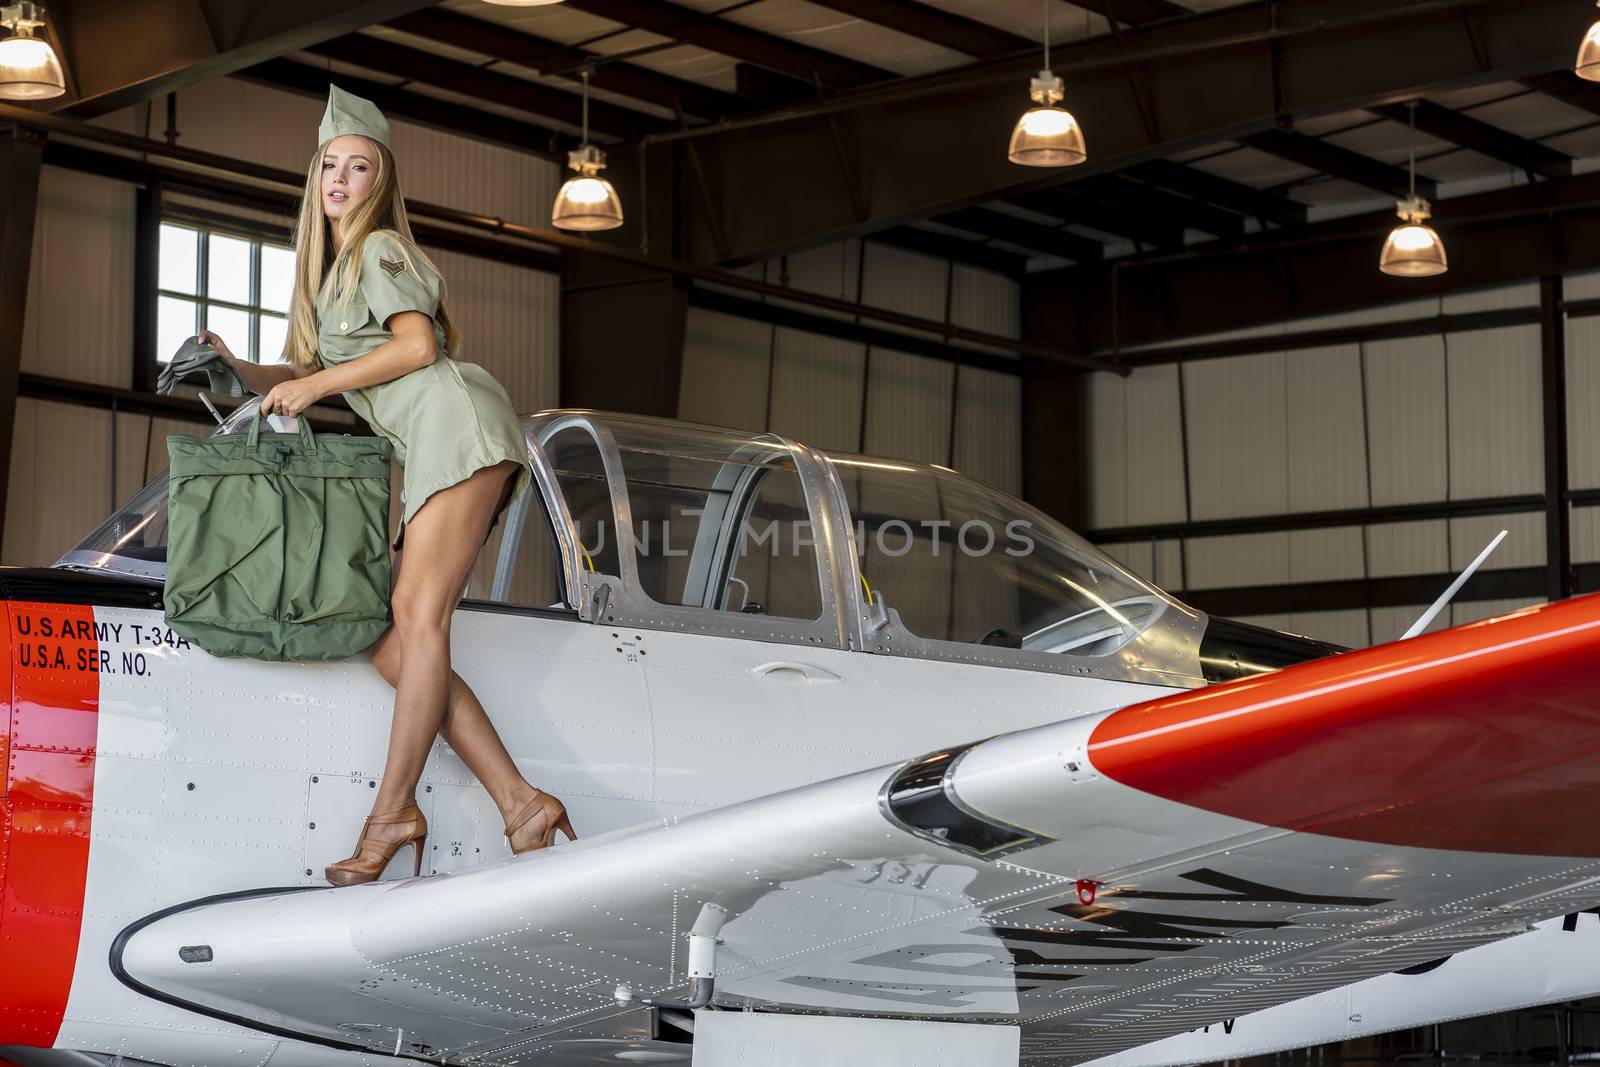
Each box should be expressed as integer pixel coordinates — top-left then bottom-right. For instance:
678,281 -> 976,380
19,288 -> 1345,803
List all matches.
309,34 -> 669,141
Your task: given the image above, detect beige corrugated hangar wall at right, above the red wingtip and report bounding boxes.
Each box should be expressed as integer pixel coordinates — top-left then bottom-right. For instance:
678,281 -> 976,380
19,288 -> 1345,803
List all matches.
1090,277 -> 1561,645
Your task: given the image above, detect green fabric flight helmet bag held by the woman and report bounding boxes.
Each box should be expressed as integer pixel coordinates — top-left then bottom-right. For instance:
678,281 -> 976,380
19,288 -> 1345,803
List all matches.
163,408 -> 392,661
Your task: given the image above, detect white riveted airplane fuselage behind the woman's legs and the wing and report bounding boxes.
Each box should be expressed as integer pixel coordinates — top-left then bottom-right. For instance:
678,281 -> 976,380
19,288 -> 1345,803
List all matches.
8,603 -> 1600,1067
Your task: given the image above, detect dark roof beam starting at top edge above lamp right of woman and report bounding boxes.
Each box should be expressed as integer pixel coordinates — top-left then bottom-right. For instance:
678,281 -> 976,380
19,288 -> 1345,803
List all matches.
566,0 -> 894,88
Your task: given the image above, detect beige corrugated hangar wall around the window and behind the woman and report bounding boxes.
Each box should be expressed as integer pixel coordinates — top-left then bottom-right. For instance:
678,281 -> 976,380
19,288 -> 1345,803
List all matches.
3,78 -> 560,565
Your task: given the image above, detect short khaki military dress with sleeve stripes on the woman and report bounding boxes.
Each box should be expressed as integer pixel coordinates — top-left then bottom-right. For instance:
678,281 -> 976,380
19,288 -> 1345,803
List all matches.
317,230 -> 533,549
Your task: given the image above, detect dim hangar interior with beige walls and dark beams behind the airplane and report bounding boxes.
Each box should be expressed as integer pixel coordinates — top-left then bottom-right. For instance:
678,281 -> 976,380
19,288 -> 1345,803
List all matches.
0,0 -> 1600,659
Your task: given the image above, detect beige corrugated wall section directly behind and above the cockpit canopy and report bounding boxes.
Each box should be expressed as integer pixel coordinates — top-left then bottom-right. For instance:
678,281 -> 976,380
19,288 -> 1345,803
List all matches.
678,240 -> 1022,493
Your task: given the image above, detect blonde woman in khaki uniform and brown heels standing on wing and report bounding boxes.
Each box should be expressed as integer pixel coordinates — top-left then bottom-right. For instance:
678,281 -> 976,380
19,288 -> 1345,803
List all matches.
200,86 -> 574,885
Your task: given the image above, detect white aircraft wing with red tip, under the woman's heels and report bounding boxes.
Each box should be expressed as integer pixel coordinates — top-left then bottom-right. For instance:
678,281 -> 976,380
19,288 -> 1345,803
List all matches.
112,597 -> 1600,1064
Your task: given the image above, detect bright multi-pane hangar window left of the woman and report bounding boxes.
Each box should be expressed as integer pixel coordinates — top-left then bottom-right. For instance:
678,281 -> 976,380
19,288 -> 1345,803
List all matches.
155,218 -> 294,363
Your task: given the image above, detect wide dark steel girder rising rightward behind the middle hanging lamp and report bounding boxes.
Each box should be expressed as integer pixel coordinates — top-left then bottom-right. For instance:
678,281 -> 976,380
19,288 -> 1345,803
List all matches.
662,0 -> 1548,262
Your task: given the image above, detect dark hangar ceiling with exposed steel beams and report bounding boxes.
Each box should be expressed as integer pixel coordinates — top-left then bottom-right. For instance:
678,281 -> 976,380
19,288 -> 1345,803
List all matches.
206,0 -> 1600,292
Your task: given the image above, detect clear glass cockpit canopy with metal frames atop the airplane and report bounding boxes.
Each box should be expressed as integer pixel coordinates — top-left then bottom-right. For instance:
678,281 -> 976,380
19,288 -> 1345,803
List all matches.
58,403 -> 1203,677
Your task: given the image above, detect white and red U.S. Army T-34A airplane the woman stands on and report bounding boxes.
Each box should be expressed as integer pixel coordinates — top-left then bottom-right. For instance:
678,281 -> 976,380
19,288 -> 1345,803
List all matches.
0,402 -> 1600,1067
